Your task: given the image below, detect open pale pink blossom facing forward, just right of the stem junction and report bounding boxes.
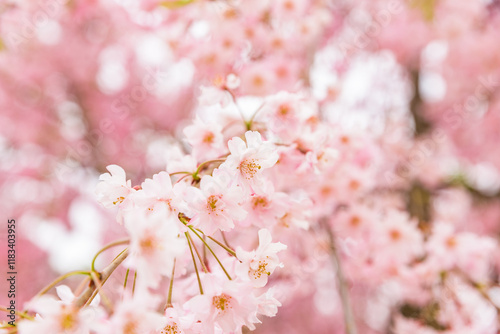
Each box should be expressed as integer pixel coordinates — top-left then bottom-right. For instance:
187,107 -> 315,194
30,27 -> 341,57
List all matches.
186,171 -> 247,235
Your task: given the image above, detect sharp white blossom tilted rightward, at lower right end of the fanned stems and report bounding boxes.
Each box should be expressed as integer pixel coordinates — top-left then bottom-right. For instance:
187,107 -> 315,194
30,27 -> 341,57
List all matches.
236,229 -> 287,288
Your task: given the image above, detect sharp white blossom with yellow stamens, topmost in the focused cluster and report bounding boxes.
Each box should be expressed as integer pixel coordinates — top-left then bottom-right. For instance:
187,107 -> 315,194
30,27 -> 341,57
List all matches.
219,131 -> 279,193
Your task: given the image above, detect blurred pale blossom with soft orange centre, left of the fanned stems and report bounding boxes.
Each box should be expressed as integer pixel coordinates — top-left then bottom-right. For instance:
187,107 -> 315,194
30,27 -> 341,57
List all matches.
125,209 -> 186,287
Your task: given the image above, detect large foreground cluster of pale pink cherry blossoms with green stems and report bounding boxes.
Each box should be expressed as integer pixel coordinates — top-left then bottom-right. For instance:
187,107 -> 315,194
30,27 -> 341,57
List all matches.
18,129 -> 288,333
